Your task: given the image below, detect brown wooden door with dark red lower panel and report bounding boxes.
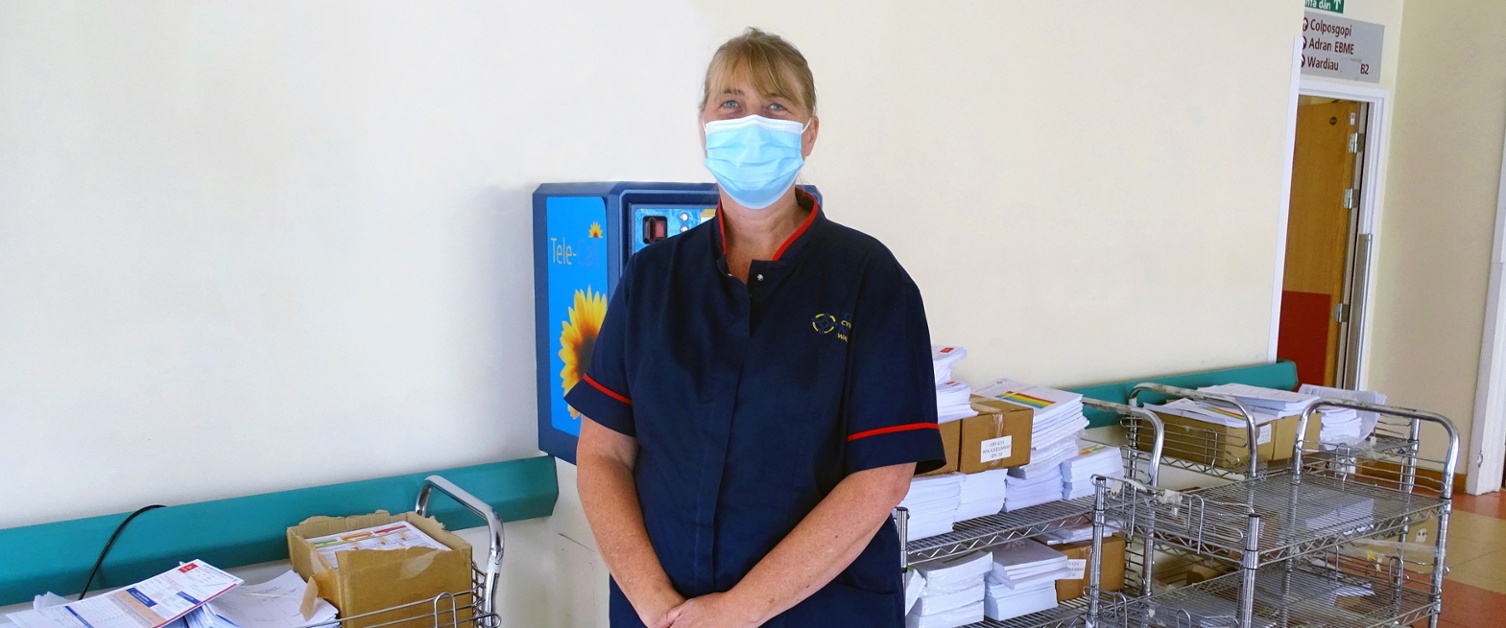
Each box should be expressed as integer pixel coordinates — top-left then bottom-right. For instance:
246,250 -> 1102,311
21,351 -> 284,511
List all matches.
1276,101 -> 1360,386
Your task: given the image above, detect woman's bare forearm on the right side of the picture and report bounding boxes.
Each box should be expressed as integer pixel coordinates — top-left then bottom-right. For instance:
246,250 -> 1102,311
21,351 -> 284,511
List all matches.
729,464 -> 916,625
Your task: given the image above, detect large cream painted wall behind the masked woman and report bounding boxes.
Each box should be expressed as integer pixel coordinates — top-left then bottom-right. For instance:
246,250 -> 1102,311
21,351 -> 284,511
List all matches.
0,0 -> 1301,526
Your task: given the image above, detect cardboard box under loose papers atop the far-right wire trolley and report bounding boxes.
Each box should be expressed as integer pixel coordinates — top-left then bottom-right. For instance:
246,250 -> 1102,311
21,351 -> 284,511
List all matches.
1136,413 -> 1322,468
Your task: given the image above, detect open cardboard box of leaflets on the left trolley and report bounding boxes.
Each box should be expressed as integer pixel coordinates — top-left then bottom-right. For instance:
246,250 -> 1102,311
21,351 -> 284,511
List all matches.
288,511 -> 474,628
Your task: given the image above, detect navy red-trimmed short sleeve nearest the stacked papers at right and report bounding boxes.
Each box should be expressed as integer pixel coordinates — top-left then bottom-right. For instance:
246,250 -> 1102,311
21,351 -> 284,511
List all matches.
843,252 -> 946,474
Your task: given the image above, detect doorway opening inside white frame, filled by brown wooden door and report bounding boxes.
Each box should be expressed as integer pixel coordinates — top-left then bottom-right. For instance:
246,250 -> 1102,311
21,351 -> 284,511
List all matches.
1276,95 -> 1372,389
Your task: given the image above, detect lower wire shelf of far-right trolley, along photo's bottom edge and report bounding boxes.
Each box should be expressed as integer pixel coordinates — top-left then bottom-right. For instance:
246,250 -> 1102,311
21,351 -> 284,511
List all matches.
1099,565 -> 1438,628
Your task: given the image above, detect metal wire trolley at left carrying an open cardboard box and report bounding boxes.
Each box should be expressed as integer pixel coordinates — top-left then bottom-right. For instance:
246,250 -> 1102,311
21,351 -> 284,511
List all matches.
319,476 -> 503,628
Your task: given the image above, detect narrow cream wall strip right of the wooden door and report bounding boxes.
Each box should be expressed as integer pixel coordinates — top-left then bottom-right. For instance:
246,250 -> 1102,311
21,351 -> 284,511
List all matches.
1369,0 -> 1506,463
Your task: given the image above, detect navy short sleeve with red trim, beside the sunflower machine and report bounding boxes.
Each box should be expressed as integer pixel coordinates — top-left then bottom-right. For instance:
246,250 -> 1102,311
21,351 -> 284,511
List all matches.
565,264 -> 637,437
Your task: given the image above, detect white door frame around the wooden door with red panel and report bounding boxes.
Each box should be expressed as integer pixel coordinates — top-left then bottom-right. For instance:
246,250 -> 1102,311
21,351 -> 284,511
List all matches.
1268,73 -> 1397,394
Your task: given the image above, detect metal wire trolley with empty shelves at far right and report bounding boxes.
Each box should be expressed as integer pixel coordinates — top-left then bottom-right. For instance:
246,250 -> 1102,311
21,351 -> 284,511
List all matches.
1089,386 -> 1459,628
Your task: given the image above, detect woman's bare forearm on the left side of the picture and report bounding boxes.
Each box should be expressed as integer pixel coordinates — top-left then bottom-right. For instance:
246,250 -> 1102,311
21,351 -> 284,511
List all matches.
575,423 -> 685,626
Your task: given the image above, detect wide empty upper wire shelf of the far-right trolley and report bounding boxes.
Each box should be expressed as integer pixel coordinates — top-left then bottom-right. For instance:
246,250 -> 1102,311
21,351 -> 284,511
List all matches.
1108,473 -> 1444,565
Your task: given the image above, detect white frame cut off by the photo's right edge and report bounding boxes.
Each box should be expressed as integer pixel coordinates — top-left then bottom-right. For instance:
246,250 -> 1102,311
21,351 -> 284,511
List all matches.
1459,115 -> 1506,495
